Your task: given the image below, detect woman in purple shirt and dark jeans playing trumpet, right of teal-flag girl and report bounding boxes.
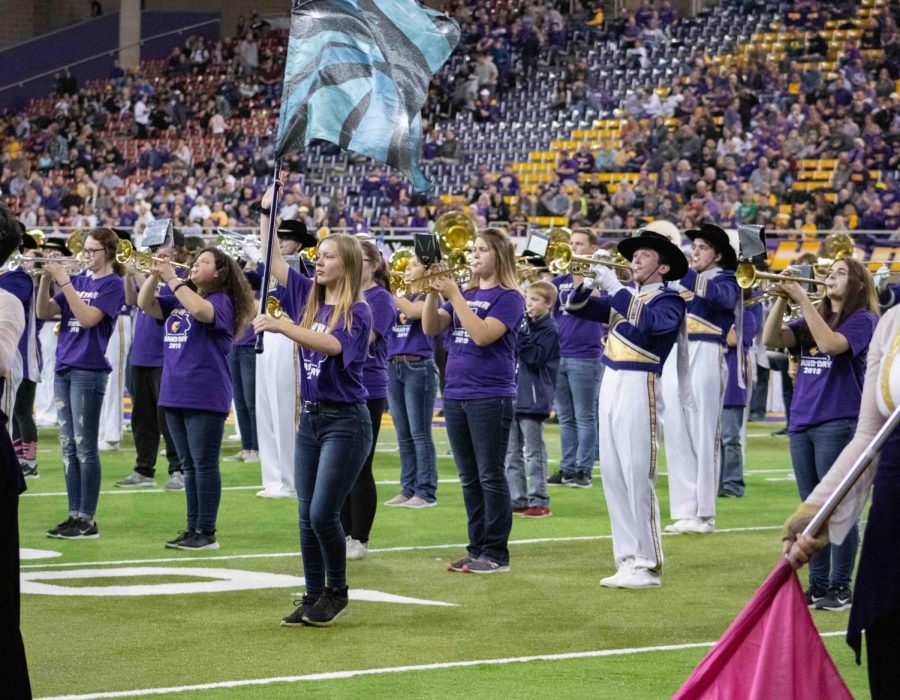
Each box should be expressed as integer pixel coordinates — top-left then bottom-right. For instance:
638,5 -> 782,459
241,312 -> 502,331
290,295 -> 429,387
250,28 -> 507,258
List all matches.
422,228 -> 525,574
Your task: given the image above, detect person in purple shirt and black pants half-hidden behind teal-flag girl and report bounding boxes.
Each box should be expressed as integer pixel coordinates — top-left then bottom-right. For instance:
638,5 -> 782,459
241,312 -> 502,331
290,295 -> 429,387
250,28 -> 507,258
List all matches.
341,241 -> 397,559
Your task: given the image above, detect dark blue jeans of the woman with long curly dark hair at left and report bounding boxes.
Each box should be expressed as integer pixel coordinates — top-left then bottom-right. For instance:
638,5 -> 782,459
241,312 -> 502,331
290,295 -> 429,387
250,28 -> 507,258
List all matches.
165,407 -> 228,535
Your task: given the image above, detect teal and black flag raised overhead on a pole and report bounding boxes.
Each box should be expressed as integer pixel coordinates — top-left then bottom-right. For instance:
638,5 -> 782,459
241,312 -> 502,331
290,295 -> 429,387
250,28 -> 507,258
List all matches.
275,0 -> 459,192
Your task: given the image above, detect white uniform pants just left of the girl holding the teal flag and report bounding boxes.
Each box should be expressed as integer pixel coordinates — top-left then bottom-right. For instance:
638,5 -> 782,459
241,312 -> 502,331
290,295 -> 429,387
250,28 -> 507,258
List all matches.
256,333 -> 300,491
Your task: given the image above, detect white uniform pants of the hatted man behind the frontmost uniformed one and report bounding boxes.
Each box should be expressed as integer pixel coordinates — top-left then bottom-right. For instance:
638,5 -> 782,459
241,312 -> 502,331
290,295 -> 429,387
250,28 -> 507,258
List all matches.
663,340 -> 728,520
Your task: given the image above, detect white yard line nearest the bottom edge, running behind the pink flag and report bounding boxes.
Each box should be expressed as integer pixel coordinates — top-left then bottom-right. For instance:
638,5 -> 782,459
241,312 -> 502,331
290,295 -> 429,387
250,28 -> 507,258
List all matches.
38,632 -> 846,700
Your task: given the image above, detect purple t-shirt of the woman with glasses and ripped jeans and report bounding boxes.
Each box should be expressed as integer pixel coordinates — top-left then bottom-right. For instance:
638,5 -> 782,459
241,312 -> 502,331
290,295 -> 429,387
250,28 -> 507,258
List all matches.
53,272 -> 125,374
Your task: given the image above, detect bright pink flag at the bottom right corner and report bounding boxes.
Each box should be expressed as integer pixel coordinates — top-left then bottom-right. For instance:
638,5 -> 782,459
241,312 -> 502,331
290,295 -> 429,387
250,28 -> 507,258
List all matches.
675,560 -> 853,700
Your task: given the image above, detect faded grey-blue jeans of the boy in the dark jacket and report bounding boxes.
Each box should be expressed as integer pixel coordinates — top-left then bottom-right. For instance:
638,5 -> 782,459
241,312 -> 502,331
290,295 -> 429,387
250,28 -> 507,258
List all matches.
506,416 -> 550,508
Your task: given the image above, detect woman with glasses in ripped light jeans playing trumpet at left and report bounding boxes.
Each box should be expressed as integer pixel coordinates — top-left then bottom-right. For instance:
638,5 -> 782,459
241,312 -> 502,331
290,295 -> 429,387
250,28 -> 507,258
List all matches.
37,228 -> 125,539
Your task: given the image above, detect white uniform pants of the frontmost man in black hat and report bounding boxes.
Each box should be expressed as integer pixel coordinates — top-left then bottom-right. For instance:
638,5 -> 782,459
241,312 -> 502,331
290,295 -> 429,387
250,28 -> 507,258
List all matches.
599,367 -> 663,572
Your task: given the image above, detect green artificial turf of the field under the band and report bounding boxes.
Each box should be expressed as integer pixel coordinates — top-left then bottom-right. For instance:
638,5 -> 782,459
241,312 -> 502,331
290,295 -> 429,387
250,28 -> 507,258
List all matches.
20,423 -> 867,698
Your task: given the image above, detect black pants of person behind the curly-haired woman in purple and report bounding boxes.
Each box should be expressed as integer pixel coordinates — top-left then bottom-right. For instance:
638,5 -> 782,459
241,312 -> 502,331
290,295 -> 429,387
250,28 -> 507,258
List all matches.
129,365 -> 181,478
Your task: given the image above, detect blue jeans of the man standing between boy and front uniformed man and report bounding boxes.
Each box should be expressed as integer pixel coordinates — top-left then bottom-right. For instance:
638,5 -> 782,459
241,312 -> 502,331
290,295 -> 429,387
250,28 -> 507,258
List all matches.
556,357 -> 603,476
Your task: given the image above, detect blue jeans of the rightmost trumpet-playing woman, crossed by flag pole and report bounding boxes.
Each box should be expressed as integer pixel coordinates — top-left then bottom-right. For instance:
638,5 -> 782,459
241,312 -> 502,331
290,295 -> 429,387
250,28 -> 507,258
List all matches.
790,418 -> 859,588
